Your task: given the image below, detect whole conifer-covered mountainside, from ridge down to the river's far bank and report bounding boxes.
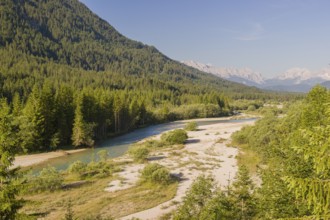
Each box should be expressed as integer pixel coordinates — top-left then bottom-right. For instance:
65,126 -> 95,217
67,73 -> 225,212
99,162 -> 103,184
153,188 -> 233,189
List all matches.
0,0 -> 302,154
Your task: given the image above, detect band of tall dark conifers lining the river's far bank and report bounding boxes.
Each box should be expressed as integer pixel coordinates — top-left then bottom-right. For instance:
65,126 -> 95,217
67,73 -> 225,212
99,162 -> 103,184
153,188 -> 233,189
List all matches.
2,81 -> 230,152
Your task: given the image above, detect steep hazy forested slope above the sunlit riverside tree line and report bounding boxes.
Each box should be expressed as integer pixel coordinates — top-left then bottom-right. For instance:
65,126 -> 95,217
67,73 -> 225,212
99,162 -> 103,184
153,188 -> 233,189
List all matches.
0,0 -> 266,99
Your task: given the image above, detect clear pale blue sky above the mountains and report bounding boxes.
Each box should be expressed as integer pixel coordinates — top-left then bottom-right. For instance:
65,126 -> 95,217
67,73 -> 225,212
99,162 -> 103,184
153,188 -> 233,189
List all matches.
80,0 -> 330,78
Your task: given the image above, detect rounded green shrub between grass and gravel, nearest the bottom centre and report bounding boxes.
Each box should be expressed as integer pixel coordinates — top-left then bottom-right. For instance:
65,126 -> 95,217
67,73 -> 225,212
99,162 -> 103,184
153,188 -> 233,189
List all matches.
142,163 -> 172,185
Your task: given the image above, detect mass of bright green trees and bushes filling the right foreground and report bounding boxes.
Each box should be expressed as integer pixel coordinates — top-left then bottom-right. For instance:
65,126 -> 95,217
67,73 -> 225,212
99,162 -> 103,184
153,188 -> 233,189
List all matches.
166,86 -> 330,220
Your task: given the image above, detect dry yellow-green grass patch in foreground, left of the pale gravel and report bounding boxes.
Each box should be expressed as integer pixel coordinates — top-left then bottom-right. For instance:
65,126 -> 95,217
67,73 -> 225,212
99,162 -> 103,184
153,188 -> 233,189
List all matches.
21,177 -> 178,219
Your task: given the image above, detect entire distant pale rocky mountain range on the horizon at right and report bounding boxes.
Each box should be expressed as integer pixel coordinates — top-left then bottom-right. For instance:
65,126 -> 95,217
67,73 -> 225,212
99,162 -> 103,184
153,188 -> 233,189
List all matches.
182,61 -> 330,92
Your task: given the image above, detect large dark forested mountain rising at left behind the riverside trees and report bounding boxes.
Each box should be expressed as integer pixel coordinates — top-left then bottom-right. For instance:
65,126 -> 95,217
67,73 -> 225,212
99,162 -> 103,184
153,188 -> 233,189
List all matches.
0,0 -> 270,97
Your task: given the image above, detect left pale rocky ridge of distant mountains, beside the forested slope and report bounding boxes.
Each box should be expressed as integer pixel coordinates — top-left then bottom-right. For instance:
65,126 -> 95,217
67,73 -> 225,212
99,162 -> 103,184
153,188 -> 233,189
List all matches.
182,61 -> 264,86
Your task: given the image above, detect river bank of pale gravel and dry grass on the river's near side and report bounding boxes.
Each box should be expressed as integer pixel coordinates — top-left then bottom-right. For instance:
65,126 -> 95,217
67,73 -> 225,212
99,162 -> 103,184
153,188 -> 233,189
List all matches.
18,118 -> 255,220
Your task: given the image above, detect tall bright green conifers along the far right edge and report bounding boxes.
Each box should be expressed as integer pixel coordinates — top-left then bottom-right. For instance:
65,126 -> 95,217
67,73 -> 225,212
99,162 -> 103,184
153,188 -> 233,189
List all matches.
285,86 -> 330,216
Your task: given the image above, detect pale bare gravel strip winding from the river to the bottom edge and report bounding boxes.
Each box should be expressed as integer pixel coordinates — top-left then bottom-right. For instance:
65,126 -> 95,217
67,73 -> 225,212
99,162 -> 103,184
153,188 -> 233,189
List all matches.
114,119 -> 254,220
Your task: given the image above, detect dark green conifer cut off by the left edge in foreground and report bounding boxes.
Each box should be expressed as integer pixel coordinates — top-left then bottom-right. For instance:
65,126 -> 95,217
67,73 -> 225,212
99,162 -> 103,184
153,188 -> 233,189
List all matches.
0,99 -> 21,220
